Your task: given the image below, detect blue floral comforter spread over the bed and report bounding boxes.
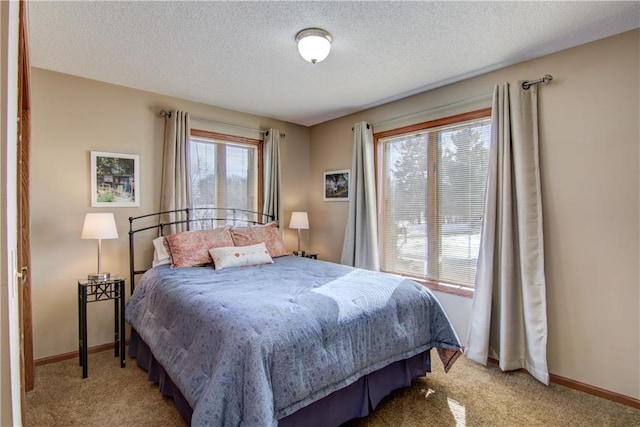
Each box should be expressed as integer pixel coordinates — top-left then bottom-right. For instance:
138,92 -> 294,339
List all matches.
126,256 -> 460,427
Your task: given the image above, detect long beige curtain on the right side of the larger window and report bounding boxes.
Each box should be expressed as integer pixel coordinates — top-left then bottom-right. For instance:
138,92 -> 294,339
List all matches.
465,82 -> 549,384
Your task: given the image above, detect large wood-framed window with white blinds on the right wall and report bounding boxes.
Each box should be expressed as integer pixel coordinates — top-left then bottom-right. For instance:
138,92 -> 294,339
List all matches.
375,109 -> 491,293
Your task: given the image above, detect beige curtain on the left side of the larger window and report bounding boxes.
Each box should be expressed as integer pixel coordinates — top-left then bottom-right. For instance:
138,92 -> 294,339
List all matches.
340,122 -> 380,271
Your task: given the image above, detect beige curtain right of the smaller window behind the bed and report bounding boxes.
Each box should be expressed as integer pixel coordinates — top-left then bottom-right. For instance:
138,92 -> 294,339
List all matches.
262,129 -> 284,224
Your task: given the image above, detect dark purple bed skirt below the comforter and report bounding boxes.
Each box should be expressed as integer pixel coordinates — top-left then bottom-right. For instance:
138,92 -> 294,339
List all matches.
129,328 -> 431,427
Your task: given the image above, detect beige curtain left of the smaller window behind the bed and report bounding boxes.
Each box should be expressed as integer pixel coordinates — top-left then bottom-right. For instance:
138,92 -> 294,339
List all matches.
160,110 -> 191,234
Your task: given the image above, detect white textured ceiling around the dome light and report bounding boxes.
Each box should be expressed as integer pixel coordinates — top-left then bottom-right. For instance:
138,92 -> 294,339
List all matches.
28,1 -> 640,126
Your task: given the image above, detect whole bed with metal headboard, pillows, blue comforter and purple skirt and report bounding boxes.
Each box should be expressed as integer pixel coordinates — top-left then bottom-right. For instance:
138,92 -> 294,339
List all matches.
126,210 -> 461,426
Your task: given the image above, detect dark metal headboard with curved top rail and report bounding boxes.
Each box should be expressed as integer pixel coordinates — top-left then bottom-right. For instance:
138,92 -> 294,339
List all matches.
129,208 -> 274,293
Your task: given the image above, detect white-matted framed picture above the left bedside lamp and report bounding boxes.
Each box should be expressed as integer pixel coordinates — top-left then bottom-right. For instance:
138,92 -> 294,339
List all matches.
91,151 -> 140,208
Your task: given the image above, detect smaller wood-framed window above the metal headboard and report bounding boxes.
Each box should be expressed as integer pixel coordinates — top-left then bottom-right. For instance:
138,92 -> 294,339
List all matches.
189,129 -> 262,227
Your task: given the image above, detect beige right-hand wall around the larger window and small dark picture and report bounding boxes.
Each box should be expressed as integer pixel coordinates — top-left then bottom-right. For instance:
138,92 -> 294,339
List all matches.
309,30 -> 640,398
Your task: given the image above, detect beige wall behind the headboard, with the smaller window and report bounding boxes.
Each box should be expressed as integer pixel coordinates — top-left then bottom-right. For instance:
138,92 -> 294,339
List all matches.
31,68 -> 309,362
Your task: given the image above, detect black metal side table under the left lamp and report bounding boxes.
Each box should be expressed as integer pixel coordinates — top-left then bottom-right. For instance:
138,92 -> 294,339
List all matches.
78,277 -> 126,378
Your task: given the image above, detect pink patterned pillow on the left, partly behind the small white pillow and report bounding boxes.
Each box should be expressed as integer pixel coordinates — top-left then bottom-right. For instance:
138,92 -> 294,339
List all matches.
166,227 -> 233,268
